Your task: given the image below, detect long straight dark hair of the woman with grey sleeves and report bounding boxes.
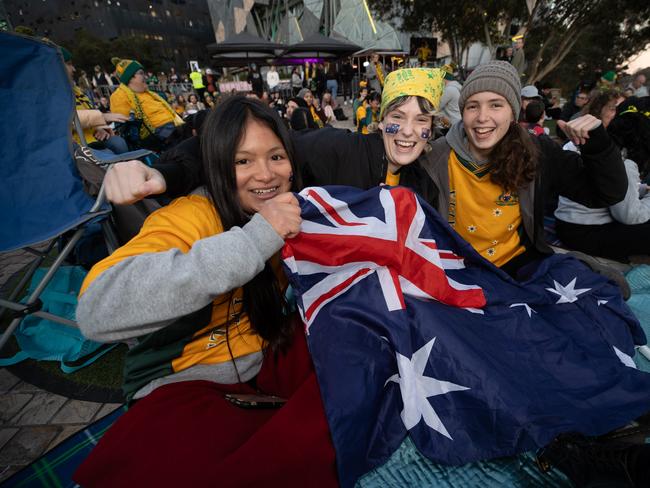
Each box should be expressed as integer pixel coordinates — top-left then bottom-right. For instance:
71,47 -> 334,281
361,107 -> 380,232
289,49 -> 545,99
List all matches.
201,96 -> 301,349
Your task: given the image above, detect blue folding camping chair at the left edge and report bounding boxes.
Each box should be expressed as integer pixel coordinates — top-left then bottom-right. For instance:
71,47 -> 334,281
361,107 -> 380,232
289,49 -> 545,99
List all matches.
0,32 -> 150,349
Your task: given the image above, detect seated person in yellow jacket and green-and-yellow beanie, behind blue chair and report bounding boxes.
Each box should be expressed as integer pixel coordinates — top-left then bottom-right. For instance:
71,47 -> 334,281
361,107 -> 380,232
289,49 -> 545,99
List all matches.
111,54 -> 183,150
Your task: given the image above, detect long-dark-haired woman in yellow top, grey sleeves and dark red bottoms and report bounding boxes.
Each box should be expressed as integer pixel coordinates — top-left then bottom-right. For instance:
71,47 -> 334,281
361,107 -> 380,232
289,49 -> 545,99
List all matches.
75,97 -> 336,487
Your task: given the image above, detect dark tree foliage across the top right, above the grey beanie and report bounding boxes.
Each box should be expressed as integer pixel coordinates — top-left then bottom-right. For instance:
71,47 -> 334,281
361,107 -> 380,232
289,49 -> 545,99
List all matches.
369,0 -> 650,83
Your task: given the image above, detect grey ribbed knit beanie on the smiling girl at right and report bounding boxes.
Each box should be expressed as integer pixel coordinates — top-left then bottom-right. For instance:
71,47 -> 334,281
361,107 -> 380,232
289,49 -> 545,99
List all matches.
458,61 -> 521,120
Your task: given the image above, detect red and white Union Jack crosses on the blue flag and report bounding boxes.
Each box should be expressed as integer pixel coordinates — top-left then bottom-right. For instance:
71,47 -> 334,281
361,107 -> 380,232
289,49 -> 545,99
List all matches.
283,187 -> 485,327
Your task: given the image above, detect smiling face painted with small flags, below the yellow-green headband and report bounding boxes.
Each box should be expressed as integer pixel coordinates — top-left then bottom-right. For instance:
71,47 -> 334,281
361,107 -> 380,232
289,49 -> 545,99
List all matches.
379,97 -> 433,173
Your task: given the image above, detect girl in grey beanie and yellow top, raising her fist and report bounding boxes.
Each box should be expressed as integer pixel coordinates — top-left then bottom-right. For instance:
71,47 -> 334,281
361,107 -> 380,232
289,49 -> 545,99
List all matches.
427,61 -> 627,278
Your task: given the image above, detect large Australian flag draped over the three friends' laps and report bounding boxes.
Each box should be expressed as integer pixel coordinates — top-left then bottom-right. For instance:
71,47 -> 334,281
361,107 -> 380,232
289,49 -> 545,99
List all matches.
283,187 -> 650,486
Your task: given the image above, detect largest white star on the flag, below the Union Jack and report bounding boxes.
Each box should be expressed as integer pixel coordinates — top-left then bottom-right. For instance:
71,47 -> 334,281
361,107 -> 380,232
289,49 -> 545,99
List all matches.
384,337 -> 469,439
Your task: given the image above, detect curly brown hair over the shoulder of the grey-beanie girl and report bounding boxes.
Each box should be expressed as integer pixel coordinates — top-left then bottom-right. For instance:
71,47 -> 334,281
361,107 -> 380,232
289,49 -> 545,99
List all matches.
488,122 -> 539,191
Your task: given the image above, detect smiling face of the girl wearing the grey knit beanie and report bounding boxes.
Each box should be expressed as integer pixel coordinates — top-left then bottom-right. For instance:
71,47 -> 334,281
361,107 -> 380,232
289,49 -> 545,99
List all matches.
463,92 -> 514,161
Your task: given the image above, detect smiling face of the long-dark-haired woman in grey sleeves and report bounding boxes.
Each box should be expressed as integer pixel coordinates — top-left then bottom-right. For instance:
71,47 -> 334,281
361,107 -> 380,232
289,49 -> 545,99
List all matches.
235,118 -> 292,214
